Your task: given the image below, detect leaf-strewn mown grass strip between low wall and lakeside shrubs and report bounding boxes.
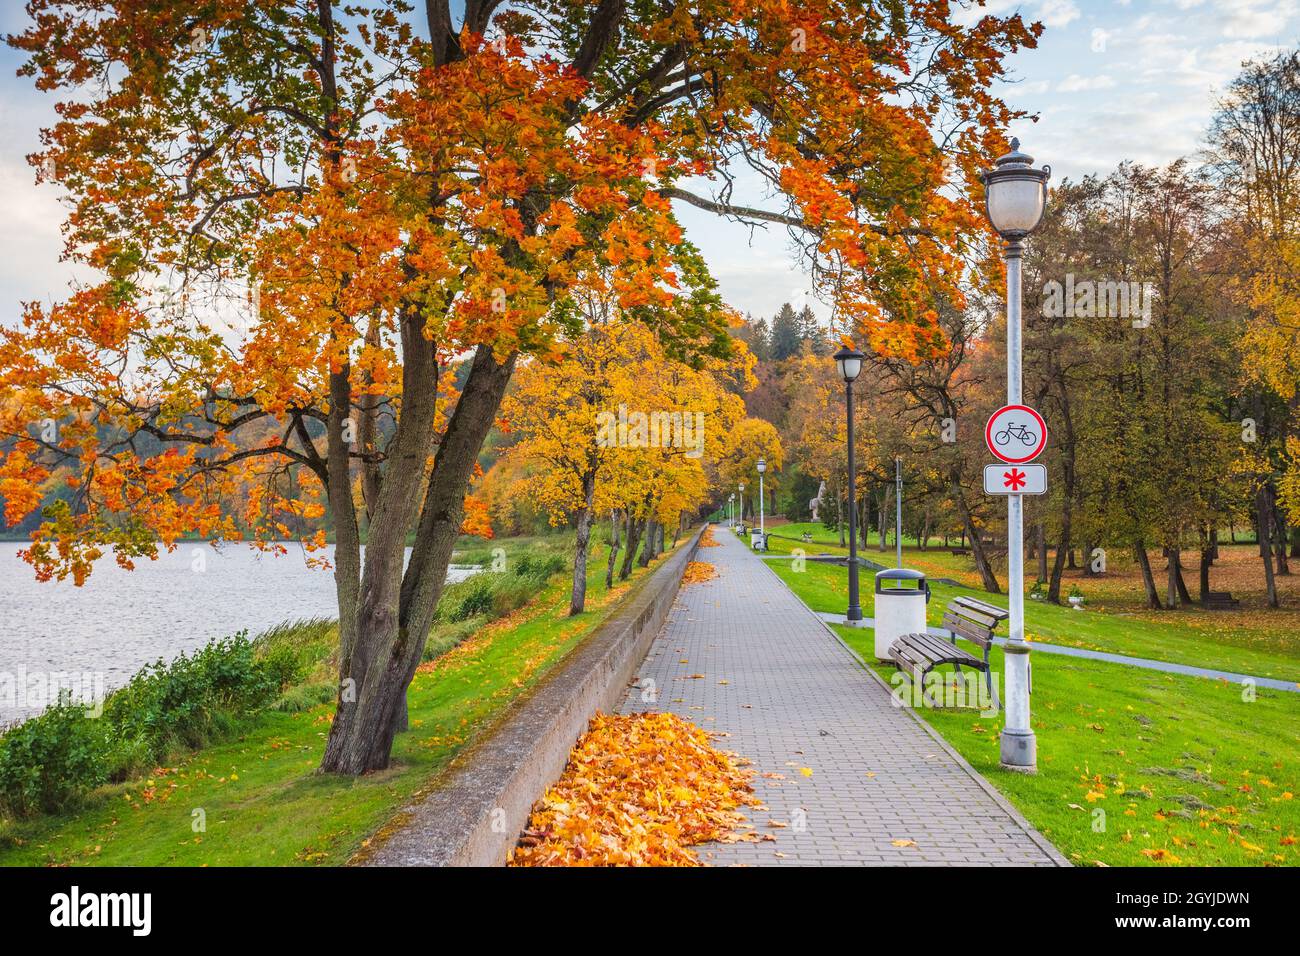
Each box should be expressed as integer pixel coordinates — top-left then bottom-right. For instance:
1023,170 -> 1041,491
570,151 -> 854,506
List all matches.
0,536 -> 665,866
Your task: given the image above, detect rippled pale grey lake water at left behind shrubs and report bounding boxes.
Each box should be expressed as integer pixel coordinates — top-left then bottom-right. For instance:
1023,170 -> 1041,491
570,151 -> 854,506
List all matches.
0,541 -> 476,726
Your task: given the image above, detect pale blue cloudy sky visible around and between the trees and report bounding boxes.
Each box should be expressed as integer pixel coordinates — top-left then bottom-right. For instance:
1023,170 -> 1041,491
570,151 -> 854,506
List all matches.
0,0 -> 1300,324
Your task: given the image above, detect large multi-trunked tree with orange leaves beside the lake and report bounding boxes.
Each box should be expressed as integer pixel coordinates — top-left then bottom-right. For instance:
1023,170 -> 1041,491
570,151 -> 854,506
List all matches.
0,0 -> 1037,774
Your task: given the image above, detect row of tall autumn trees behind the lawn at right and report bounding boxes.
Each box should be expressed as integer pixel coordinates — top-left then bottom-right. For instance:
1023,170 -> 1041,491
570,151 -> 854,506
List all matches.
759,52 -> 1300,609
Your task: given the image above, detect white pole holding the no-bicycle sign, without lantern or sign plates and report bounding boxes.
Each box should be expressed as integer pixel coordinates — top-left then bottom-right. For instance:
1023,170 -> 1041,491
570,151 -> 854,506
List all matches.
1000,239 -> 1045,773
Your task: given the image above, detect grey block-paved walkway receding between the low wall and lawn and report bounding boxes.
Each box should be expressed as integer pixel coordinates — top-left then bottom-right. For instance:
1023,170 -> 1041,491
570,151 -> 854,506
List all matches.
621,533 -> 1066,866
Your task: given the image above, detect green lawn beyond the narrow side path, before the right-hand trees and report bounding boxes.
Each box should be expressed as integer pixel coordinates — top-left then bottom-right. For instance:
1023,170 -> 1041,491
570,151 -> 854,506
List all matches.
768,538 -> 1300,682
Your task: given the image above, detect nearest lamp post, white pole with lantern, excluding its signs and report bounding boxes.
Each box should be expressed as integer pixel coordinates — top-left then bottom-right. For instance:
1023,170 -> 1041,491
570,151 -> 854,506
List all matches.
982,139 -> 1052,773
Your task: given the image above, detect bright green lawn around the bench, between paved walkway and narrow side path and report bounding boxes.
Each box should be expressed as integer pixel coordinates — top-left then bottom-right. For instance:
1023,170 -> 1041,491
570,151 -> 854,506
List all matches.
754,546 -> 1300,866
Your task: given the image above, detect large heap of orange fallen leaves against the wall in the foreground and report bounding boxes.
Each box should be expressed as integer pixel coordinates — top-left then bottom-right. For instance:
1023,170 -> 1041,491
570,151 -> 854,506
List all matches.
510,713 -> 761,866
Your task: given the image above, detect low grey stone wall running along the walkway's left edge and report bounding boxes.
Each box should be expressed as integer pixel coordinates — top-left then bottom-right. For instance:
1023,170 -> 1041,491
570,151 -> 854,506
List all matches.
361,528 -> 703,866
